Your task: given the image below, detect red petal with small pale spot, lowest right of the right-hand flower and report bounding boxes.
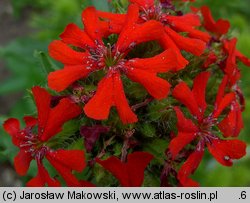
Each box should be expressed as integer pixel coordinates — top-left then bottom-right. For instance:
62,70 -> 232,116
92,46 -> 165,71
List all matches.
207,139 -> 246,166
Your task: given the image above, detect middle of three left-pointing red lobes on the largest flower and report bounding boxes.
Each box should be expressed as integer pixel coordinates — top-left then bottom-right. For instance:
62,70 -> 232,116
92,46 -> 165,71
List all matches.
49,40 -> 88,65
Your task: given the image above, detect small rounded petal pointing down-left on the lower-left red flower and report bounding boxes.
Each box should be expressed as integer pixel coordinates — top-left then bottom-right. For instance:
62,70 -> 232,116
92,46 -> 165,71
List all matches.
14,150 -> 32,176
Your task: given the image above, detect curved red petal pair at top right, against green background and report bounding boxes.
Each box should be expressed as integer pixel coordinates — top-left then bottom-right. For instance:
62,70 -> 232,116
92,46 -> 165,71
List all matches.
200,6 -> 230,36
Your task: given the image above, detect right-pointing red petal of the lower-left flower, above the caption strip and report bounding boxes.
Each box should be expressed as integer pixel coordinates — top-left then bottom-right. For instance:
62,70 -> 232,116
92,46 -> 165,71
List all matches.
47,150 -> 86,172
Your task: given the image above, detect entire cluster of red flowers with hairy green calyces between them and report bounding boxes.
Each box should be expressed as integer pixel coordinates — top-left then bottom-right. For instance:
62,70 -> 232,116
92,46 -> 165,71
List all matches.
3,0 -> 250,186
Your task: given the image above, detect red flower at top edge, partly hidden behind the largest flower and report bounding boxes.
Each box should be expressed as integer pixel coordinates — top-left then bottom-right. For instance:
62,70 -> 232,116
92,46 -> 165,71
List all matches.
99,0 -> 210,70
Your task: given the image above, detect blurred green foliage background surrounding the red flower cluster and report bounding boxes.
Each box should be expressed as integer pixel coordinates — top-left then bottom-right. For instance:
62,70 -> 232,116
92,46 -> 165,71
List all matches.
0,0 -> 250,186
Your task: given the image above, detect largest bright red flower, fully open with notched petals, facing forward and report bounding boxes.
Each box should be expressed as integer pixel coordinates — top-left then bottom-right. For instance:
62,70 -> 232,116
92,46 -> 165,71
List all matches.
48,5 -> 176,123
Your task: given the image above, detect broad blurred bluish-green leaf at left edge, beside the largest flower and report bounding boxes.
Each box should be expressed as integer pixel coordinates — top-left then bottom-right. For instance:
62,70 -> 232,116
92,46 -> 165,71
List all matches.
0,38 -> 47,94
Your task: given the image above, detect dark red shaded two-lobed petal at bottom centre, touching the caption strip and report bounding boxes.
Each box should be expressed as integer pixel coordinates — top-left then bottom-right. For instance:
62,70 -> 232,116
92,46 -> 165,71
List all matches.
96,152 -> 153,187
